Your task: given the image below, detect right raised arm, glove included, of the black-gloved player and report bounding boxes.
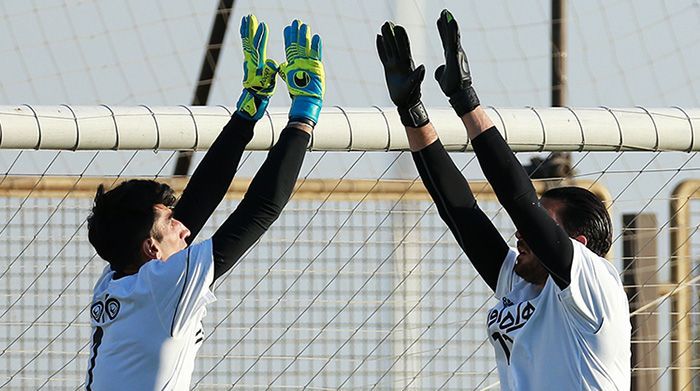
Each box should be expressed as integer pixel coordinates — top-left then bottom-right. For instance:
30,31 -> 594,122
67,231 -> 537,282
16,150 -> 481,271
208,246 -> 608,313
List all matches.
435,10 -> 573,289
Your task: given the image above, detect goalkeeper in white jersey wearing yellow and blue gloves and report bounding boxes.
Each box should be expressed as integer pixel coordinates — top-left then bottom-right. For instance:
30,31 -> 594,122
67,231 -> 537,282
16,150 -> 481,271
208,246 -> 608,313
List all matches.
85,15 -> 325,390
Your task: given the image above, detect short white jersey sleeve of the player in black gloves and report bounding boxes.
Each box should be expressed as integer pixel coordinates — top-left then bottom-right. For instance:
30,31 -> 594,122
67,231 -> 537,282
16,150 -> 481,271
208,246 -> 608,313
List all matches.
559,239 -> 626,333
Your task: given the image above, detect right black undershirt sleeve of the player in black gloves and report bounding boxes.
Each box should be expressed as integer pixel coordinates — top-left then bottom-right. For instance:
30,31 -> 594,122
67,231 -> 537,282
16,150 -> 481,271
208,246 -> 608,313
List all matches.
472,127 -> 574,289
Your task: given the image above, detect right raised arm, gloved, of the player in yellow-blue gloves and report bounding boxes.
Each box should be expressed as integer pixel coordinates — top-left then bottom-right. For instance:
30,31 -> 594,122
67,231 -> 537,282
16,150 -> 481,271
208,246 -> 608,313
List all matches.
212,20 -> 325,280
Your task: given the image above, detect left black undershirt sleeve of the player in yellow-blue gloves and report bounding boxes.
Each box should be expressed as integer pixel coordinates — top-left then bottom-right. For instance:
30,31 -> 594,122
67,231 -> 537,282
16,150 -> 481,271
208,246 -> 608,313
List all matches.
173,114 -> 255,245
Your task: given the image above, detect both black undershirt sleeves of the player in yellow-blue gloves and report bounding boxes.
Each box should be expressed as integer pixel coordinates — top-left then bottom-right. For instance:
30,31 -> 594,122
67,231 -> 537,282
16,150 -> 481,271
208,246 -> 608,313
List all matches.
173,114 -> 310,280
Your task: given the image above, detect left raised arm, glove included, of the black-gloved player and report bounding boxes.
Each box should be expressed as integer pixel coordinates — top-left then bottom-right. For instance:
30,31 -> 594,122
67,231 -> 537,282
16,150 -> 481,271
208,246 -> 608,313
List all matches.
377,22 -> 508,290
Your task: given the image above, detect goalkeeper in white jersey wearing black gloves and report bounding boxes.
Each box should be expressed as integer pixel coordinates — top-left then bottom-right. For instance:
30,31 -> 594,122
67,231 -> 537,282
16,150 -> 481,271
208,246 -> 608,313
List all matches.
377,10 -> 631,390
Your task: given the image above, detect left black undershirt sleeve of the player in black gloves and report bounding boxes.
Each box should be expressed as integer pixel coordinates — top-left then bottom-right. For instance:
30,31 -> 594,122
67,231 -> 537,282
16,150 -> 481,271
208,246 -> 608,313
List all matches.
412,140 -> 508,290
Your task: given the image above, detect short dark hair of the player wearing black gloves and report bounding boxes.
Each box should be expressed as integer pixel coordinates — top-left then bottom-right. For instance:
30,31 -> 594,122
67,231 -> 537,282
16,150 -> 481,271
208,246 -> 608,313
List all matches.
542,187 -> 612,257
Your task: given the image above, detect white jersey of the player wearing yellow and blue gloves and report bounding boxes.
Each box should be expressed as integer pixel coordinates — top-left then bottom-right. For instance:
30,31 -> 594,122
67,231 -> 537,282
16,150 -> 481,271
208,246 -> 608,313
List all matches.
85,240 -> 216,391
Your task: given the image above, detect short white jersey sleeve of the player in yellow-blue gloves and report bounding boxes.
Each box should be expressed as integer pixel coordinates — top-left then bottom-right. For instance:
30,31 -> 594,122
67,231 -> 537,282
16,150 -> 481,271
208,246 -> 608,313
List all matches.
142,239 -> 216,337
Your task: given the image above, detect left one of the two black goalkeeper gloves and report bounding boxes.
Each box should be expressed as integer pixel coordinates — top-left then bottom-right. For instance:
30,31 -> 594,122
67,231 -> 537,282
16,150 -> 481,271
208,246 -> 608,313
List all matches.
377,22 -> 429,128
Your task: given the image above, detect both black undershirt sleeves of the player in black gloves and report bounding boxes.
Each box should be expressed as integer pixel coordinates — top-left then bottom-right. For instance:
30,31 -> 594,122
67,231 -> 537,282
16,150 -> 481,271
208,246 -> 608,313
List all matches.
413,127 -> 573,290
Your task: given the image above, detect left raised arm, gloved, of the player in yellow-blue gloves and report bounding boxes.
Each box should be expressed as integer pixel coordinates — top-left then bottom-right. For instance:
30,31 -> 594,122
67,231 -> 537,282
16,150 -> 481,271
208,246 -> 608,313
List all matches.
174,15 -> 278,244
